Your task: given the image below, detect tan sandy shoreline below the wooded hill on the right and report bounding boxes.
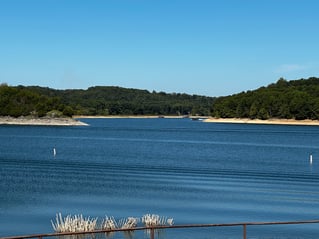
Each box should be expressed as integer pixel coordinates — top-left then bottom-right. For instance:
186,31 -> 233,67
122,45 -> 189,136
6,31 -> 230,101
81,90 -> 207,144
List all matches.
203,118 -> 319,126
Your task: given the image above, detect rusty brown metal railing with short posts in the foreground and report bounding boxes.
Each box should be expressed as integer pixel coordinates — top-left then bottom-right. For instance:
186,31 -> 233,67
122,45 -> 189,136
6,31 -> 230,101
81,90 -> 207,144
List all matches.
0,220 -> 319,239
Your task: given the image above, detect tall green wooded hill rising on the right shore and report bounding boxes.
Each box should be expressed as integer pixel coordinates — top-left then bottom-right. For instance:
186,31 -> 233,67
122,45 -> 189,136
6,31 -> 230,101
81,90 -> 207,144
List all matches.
212,77 -> 319,120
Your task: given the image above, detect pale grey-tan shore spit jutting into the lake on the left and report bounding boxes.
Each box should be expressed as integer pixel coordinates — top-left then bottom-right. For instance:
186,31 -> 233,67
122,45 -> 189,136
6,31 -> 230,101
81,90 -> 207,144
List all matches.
0,116 -> 87,126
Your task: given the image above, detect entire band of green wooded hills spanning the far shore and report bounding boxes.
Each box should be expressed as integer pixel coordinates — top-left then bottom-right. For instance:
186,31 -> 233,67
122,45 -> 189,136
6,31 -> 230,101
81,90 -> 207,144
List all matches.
0,77 -> 319,120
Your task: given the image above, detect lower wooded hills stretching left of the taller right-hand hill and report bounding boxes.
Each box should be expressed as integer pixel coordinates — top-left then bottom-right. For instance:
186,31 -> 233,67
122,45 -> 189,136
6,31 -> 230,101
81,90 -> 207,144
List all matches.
0,84 -> 215,117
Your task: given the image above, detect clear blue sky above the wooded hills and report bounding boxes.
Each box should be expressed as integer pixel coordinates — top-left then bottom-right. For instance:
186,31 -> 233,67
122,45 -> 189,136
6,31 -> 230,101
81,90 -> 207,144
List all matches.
0,0 -> 319,96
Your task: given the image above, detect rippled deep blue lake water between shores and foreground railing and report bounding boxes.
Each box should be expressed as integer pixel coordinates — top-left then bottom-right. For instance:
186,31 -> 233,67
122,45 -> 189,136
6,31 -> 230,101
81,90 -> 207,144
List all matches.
0,119 -> 319,239
